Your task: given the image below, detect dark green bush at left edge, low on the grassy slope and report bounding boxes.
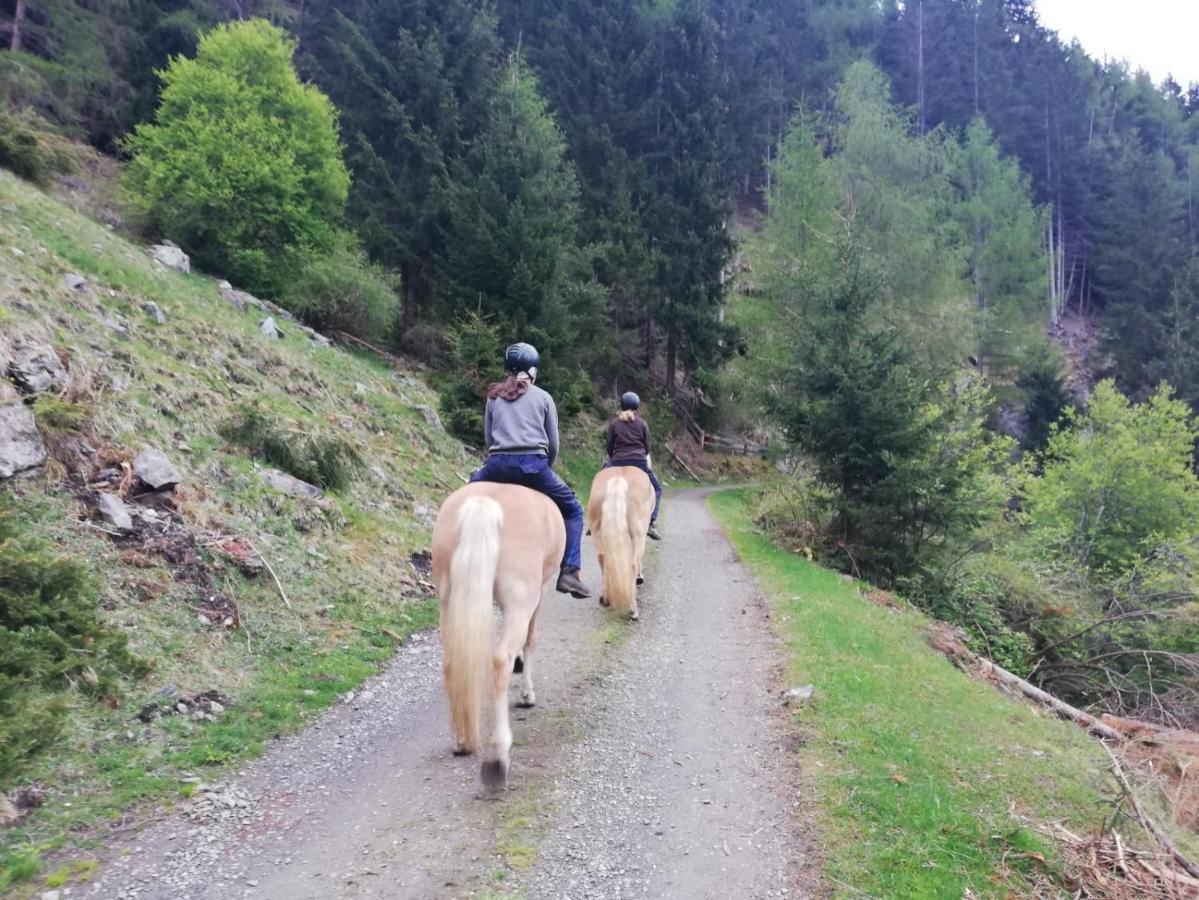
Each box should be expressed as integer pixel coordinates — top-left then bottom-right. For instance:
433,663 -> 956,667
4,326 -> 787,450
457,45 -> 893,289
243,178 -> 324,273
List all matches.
0,496 -> 147,787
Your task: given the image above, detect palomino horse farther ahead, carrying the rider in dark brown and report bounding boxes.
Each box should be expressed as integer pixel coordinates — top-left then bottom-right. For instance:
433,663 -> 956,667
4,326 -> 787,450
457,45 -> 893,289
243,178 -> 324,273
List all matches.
588,466 -> 653,618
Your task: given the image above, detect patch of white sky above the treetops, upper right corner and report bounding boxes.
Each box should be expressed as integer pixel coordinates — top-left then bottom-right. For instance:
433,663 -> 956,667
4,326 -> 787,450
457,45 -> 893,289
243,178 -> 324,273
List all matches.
1036,0 -> 1199,87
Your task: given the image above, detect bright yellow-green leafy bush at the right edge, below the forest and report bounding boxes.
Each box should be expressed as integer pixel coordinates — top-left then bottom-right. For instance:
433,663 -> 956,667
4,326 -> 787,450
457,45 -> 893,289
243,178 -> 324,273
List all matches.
1024,381 -> 1199,573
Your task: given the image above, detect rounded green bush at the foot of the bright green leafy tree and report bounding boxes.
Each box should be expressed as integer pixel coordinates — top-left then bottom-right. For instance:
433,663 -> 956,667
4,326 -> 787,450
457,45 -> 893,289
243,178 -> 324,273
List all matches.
283,249 -> 399,340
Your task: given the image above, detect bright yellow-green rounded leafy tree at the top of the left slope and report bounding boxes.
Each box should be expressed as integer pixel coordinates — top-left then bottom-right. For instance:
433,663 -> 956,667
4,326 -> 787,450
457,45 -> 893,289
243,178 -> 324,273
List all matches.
126,19 -> 349,294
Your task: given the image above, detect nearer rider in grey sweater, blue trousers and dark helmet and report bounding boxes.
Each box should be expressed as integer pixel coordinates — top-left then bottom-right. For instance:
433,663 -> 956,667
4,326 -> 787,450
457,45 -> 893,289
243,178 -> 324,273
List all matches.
470,343 -> 591,599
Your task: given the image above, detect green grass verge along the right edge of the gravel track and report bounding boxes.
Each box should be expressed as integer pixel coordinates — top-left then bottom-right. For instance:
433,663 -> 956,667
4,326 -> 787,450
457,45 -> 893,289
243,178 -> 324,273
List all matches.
710,491 -> 1127,898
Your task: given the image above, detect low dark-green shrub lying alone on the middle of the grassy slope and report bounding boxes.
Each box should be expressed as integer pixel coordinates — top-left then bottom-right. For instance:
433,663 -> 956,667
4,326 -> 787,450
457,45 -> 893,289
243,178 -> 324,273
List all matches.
224,404 -> 362,490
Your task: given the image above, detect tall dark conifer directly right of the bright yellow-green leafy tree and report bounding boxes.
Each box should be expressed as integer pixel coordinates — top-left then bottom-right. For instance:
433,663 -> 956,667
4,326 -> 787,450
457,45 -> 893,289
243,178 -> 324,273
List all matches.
308,0 -> 499,327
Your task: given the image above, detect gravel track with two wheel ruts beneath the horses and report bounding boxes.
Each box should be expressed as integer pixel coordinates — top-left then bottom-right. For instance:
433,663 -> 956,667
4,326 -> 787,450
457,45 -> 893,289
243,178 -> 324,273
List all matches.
86,491 -> 813,900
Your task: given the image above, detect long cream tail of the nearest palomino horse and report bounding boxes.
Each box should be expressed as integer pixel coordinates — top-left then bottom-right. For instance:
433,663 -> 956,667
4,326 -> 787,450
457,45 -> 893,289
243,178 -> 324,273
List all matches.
441,497 -> 504,753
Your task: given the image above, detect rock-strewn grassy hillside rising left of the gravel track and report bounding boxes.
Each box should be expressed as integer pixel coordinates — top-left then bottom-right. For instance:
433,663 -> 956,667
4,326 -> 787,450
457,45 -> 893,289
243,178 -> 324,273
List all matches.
0,171 -> 471,889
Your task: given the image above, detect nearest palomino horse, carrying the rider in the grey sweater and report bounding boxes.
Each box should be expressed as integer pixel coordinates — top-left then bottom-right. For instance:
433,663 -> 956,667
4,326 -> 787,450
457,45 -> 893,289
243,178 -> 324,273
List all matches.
433,482 -> 566,793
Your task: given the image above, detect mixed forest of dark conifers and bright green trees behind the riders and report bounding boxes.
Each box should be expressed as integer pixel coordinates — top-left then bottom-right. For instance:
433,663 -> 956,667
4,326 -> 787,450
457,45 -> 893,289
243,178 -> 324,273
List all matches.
0,0 -> 1199,726
